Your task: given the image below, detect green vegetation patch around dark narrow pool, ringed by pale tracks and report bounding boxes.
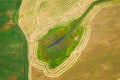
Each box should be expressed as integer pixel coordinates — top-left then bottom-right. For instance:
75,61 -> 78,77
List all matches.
38,20 -> 85,68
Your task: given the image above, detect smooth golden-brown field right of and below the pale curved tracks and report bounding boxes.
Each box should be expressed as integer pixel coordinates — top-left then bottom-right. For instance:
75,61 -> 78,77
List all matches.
32,2 -> 120,80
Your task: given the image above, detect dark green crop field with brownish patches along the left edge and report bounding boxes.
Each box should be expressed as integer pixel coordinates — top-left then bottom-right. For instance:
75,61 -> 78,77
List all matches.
0,0 -> 28,80
